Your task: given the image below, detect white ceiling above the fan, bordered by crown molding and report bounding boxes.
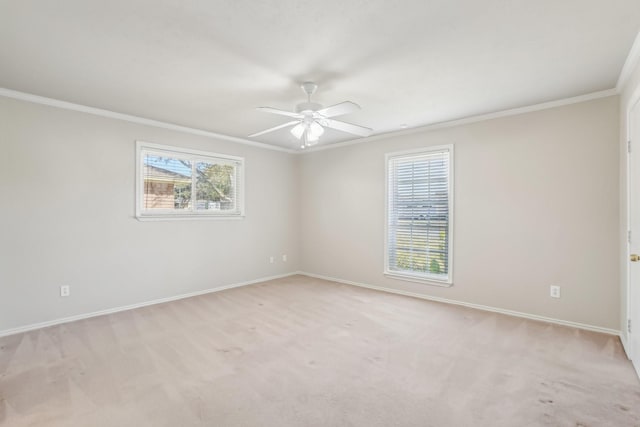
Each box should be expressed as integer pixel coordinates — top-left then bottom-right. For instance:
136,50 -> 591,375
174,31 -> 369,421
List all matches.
0,0 -> 640,148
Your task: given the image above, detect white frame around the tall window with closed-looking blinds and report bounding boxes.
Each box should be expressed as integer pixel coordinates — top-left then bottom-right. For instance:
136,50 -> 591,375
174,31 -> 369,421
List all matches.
384,144 -> 455,287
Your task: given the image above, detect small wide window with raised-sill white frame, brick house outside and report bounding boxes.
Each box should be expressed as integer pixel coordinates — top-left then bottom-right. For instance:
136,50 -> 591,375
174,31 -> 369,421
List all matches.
136,141 -> 244,219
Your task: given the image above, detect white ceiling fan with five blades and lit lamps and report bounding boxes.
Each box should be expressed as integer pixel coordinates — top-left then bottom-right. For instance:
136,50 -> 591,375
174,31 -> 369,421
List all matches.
249,82 -> 373,148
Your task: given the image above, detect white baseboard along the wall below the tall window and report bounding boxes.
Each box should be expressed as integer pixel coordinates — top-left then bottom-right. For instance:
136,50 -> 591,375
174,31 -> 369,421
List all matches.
297,271 -> 620,336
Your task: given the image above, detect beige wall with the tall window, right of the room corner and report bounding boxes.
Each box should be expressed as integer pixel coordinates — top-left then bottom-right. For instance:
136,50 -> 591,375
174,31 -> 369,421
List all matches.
300,96 -> 620,330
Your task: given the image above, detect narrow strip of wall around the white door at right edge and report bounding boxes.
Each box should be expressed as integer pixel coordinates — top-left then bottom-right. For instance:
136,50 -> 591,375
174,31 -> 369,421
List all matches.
619,56 -> 640,342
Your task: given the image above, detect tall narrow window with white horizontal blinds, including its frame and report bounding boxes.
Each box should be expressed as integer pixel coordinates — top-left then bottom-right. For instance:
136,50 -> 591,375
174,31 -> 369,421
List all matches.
385,145 -> 453,285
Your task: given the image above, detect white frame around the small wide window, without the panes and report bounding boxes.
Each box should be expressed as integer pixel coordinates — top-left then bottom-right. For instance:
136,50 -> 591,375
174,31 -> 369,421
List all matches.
135,141 -> 245,221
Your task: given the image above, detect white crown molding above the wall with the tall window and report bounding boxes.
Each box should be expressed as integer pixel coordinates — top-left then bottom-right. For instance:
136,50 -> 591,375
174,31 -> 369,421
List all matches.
296,88 -> 618,154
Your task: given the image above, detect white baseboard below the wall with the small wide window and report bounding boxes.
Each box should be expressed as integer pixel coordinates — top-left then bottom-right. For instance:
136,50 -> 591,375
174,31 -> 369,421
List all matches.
0,272 -> 298,337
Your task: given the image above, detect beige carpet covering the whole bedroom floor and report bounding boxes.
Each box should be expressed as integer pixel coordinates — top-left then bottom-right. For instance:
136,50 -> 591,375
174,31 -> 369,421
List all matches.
0,276 -> 640,427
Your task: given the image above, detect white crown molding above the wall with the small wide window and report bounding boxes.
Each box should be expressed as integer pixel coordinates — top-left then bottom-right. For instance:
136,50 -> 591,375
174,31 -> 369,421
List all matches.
0,87 -> 298,154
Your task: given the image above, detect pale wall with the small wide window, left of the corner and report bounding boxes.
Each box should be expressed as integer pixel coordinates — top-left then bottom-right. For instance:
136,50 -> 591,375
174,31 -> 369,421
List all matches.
0,97 -> 299,332
